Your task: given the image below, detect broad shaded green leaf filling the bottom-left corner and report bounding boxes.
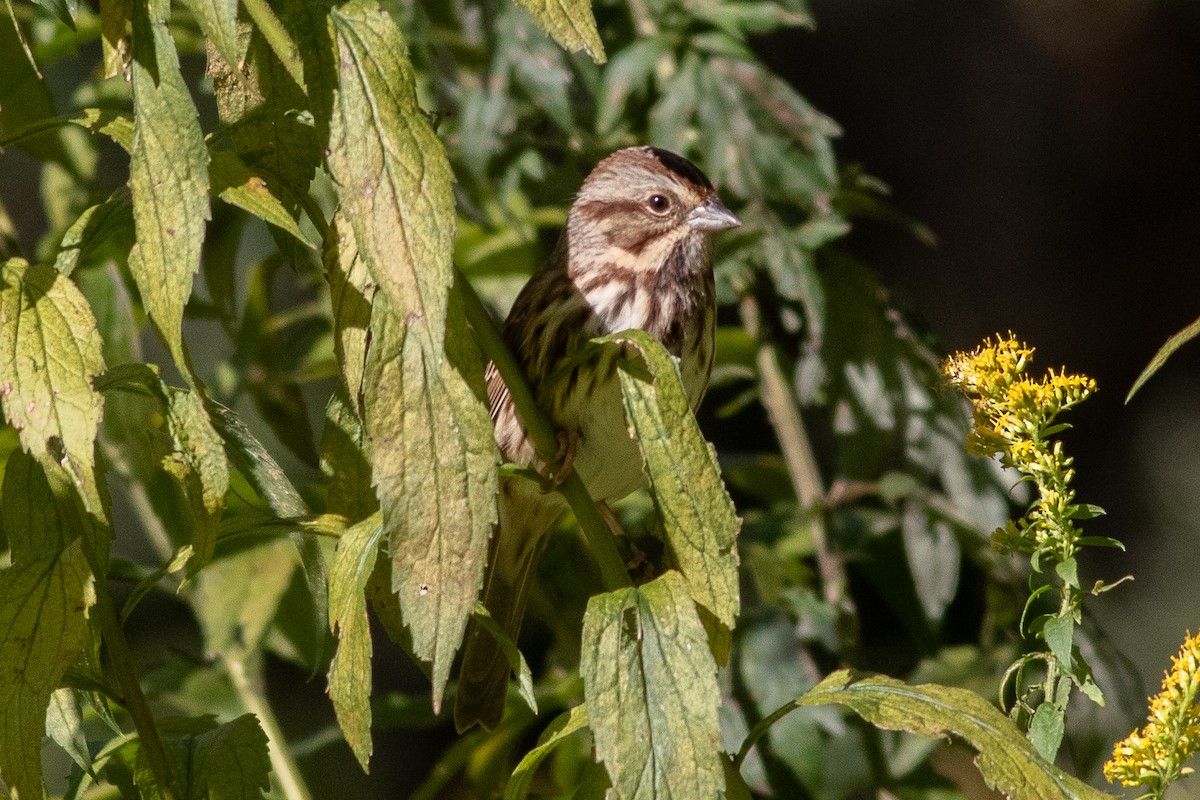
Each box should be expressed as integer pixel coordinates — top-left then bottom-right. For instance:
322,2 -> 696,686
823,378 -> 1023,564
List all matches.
0,540 -> 95,798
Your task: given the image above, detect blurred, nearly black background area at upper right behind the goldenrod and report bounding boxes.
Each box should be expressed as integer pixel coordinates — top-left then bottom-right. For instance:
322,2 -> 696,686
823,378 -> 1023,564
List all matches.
760,0 -> 1200,700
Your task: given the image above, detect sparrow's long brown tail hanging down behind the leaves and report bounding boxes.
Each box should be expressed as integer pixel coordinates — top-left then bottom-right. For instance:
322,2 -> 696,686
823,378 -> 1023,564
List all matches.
454,477 -> 565,732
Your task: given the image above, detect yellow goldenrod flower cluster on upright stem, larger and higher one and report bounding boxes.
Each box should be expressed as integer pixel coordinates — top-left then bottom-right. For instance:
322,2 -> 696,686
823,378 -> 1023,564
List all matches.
944,333 -> 1096,558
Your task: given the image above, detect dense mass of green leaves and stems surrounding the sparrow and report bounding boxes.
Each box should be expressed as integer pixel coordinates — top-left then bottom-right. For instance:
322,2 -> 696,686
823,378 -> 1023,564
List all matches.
0,0 -> 1171,800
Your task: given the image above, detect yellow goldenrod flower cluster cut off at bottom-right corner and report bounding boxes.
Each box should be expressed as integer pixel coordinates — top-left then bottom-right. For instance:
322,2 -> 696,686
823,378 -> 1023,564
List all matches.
1104,632 -> 1200,798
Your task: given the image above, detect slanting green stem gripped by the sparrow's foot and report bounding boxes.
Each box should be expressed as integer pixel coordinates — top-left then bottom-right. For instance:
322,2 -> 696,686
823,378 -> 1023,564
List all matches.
455,270 -> 632,591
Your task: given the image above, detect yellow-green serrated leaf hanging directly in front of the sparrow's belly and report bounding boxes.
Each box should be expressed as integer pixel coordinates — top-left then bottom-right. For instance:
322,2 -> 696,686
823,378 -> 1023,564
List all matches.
600,331 -> 742,628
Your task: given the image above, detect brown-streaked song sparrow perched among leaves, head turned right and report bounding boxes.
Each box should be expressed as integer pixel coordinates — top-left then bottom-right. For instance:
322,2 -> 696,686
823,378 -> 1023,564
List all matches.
455,148 -> 740,730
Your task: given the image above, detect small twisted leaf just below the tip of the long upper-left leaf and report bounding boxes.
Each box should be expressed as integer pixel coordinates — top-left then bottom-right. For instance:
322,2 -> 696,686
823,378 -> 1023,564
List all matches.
163,389 -> 229,576
